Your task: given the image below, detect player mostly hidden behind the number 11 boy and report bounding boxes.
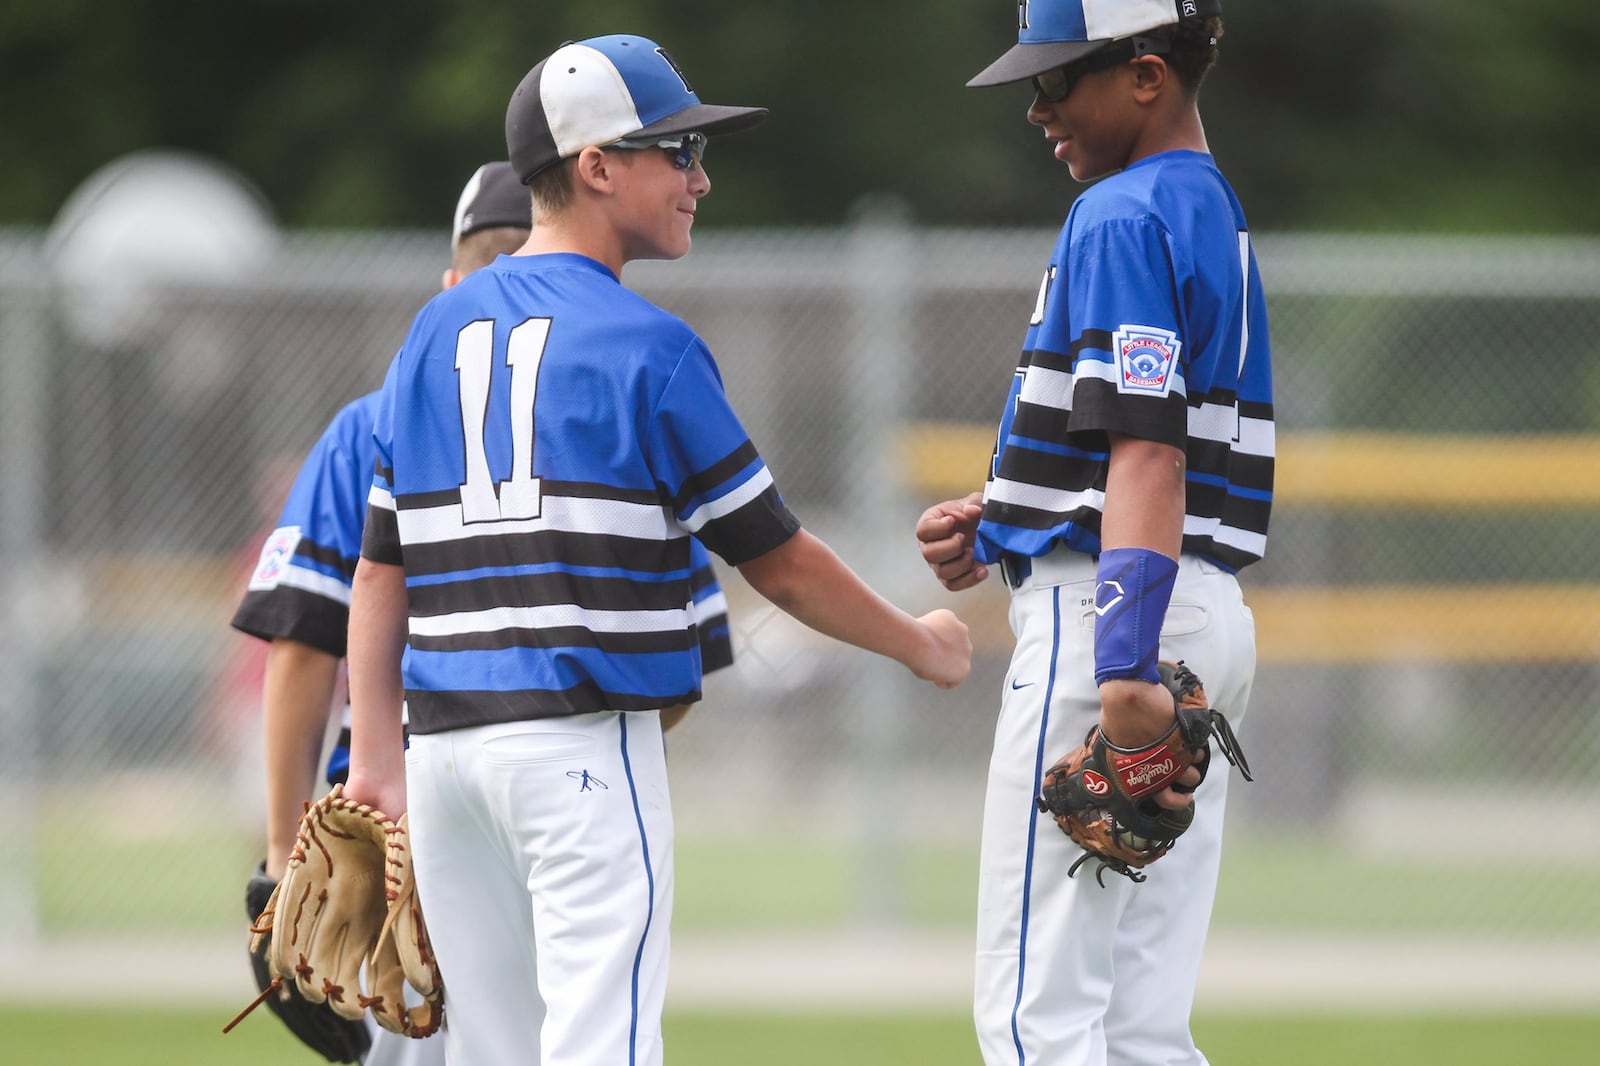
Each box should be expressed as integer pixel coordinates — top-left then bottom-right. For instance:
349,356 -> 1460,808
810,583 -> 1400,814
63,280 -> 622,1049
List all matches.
232,162 -> 733,1066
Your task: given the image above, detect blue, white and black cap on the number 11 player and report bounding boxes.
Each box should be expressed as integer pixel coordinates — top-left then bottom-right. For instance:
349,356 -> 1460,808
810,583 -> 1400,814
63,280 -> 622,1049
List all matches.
506,34 -> 766,182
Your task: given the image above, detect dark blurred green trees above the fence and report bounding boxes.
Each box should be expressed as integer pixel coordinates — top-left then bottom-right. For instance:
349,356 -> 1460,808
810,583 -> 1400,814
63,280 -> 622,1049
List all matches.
0,0 -> 1600,232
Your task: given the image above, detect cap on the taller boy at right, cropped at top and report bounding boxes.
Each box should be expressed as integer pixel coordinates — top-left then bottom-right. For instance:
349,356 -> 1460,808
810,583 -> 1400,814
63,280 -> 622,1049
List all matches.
966,0 -> 1222,88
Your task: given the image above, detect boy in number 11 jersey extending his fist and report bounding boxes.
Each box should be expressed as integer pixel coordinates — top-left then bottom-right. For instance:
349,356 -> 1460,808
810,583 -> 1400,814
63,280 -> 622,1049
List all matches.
346,35 -> 971,1066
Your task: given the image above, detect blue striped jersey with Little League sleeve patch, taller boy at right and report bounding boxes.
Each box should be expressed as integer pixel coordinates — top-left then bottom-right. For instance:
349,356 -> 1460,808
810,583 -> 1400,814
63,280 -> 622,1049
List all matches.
974,150 -> 1275,570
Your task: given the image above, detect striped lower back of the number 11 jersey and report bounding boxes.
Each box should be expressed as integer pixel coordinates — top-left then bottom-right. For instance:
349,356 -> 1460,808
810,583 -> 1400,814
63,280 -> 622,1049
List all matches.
368,467 -> 798,731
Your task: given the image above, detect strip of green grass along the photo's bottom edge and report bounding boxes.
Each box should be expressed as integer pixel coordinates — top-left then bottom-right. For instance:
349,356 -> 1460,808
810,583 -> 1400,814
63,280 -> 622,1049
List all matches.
12,1007 -> 1600,1066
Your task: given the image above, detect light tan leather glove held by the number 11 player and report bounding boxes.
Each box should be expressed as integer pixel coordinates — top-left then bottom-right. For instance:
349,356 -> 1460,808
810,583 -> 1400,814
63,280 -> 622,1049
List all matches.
224,784 -> 445,1037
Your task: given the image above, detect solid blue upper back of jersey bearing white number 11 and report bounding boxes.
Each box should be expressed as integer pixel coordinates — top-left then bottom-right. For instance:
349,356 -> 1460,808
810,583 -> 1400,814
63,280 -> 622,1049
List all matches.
394,254 -> 694,496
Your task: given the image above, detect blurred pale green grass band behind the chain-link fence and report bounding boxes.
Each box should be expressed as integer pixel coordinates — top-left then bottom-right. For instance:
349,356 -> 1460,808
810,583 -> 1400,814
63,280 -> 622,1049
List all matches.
37,823 -> 1600,938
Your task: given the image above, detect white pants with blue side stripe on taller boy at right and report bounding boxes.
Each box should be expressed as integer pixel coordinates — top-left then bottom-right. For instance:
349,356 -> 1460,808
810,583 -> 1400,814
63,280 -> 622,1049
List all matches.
973,549 -> 1256,1066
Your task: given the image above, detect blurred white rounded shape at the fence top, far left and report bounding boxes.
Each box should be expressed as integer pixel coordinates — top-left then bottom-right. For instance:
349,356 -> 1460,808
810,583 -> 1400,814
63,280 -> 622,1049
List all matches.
45,150 -> 278,347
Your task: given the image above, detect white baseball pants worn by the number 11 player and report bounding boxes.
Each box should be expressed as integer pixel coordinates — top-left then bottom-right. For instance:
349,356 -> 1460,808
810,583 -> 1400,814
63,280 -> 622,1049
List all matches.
406,712 -> 672,1066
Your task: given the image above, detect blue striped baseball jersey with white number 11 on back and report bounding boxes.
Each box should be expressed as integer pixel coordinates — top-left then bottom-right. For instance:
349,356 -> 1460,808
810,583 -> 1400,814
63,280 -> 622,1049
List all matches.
362,253 -> 800,733
